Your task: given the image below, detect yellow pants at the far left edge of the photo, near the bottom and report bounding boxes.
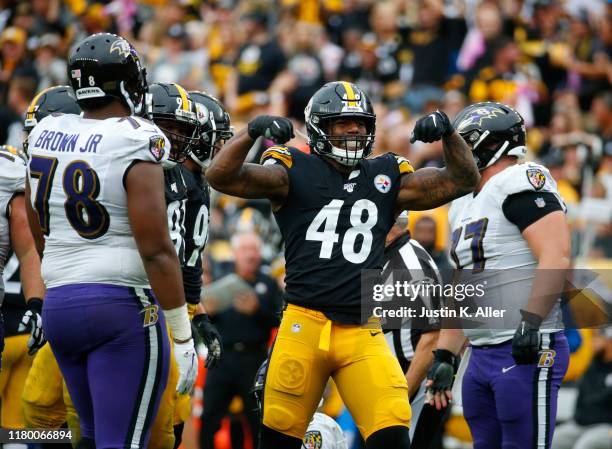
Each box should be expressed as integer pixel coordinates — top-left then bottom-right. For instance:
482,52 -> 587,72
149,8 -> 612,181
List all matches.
0,334 -> 33,429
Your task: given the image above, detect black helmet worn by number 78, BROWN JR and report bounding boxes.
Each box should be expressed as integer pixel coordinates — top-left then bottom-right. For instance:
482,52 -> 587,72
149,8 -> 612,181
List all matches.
68,33 -> 147,114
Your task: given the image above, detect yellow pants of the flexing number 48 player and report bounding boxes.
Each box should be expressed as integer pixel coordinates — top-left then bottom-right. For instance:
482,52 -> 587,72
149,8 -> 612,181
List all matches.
263,304 -> 411,439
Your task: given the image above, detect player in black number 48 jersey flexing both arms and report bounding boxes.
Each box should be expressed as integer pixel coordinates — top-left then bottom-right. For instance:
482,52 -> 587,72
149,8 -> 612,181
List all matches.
207,82 -> 479,449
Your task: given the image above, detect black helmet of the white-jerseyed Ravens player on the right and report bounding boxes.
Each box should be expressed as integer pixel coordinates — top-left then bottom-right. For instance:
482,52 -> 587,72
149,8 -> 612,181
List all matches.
453,101 -> 527,170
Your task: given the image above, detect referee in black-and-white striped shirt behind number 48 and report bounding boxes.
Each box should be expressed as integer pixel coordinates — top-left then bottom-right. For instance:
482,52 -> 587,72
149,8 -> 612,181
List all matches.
382,211 -> 444,449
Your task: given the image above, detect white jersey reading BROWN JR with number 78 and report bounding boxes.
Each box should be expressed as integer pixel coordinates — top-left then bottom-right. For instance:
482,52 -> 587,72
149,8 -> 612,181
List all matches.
28,114 -> 170,288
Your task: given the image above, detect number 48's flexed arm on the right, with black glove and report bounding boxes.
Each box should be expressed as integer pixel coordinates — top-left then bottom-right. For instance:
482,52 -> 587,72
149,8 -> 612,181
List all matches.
397,111 -> 480,211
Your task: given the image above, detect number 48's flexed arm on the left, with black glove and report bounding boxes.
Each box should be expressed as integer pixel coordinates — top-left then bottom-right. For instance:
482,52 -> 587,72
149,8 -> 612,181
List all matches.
206,116 -> 293,205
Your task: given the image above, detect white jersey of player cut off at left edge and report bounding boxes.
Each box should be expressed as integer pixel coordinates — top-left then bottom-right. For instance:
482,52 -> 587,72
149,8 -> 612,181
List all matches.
0,148 -> 26,304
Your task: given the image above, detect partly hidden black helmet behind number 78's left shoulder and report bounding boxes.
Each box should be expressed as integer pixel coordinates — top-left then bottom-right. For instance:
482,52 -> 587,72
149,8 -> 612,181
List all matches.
24,86 -> 81,134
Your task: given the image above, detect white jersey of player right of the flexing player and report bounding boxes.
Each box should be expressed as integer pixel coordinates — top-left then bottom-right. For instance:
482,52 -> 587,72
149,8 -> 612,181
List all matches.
449,162 -> 565,345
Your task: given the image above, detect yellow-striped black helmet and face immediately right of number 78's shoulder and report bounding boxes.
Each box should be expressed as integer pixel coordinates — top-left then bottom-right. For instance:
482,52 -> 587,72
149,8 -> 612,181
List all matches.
145,83 -> 200,163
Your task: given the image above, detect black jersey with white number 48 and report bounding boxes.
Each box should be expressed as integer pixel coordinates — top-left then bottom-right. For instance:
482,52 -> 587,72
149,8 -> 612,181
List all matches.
262,146 -> 413,324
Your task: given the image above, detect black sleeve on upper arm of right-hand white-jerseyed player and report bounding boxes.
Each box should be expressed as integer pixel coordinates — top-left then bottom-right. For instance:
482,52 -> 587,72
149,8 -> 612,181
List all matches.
502,191 -> 563,232
